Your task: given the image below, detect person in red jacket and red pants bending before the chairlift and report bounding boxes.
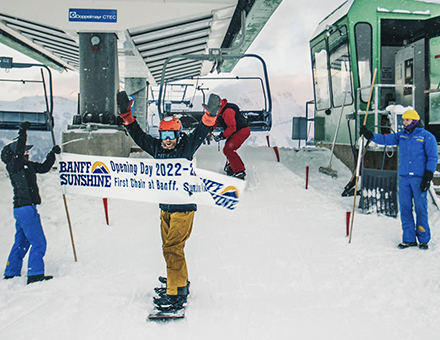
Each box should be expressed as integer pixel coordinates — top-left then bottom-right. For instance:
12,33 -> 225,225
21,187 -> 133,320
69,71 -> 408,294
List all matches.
204,93 -> 251,179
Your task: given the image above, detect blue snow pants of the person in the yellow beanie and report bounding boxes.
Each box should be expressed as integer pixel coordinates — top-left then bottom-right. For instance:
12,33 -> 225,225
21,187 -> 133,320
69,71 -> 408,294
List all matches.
399,176 -> 431,243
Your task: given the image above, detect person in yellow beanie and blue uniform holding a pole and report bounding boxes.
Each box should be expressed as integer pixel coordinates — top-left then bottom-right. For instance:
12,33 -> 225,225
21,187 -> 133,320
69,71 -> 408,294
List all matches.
360,109 -> 438,249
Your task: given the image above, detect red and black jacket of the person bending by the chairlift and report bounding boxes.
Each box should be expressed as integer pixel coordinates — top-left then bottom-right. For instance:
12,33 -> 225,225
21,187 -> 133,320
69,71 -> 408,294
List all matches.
214,99 -> 249,139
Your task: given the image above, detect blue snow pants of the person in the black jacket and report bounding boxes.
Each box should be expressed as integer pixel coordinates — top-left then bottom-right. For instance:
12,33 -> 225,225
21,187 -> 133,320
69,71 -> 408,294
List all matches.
5,205 -> 46,276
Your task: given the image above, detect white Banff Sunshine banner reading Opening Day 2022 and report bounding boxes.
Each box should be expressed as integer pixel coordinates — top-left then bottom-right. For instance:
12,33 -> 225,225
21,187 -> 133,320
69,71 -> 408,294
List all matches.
58,153 -> 246,210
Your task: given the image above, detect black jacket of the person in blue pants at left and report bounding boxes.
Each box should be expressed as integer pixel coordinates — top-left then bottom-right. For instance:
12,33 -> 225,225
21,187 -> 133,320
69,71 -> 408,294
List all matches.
1,134 -> 55,208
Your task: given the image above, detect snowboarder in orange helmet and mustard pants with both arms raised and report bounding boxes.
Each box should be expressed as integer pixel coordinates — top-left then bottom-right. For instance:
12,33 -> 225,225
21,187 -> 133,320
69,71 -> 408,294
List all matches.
117,91 -> 216,310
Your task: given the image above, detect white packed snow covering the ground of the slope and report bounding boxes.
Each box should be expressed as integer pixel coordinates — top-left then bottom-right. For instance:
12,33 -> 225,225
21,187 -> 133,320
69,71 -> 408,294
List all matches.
0,145 -> 440,340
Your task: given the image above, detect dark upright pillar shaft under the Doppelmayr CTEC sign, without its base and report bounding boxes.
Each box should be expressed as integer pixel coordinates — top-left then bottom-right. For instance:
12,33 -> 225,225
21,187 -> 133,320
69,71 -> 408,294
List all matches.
79,33 -> 119,124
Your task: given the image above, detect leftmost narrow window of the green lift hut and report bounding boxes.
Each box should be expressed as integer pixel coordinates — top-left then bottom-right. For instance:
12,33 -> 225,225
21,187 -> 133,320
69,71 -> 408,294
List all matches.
312,40 -> 330,110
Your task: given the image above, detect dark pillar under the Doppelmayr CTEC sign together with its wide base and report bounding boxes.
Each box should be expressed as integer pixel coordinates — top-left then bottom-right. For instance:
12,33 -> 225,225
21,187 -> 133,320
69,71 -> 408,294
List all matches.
62,33 -> 133,157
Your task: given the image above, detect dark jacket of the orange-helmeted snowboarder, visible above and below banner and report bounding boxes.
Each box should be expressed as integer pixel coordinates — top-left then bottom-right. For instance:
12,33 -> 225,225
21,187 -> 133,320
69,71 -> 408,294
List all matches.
125,121 -> 212,213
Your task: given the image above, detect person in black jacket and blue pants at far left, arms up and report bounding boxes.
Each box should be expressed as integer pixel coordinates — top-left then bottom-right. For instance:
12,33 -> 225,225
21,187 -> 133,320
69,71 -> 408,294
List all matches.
1,122 -> 61,284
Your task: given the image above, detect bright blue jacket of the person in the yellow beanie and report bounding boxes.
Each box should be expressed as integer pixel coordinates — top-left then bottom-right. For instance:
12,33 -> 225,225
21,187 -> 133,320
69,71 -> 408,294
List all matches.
372,121 -> 438,177
